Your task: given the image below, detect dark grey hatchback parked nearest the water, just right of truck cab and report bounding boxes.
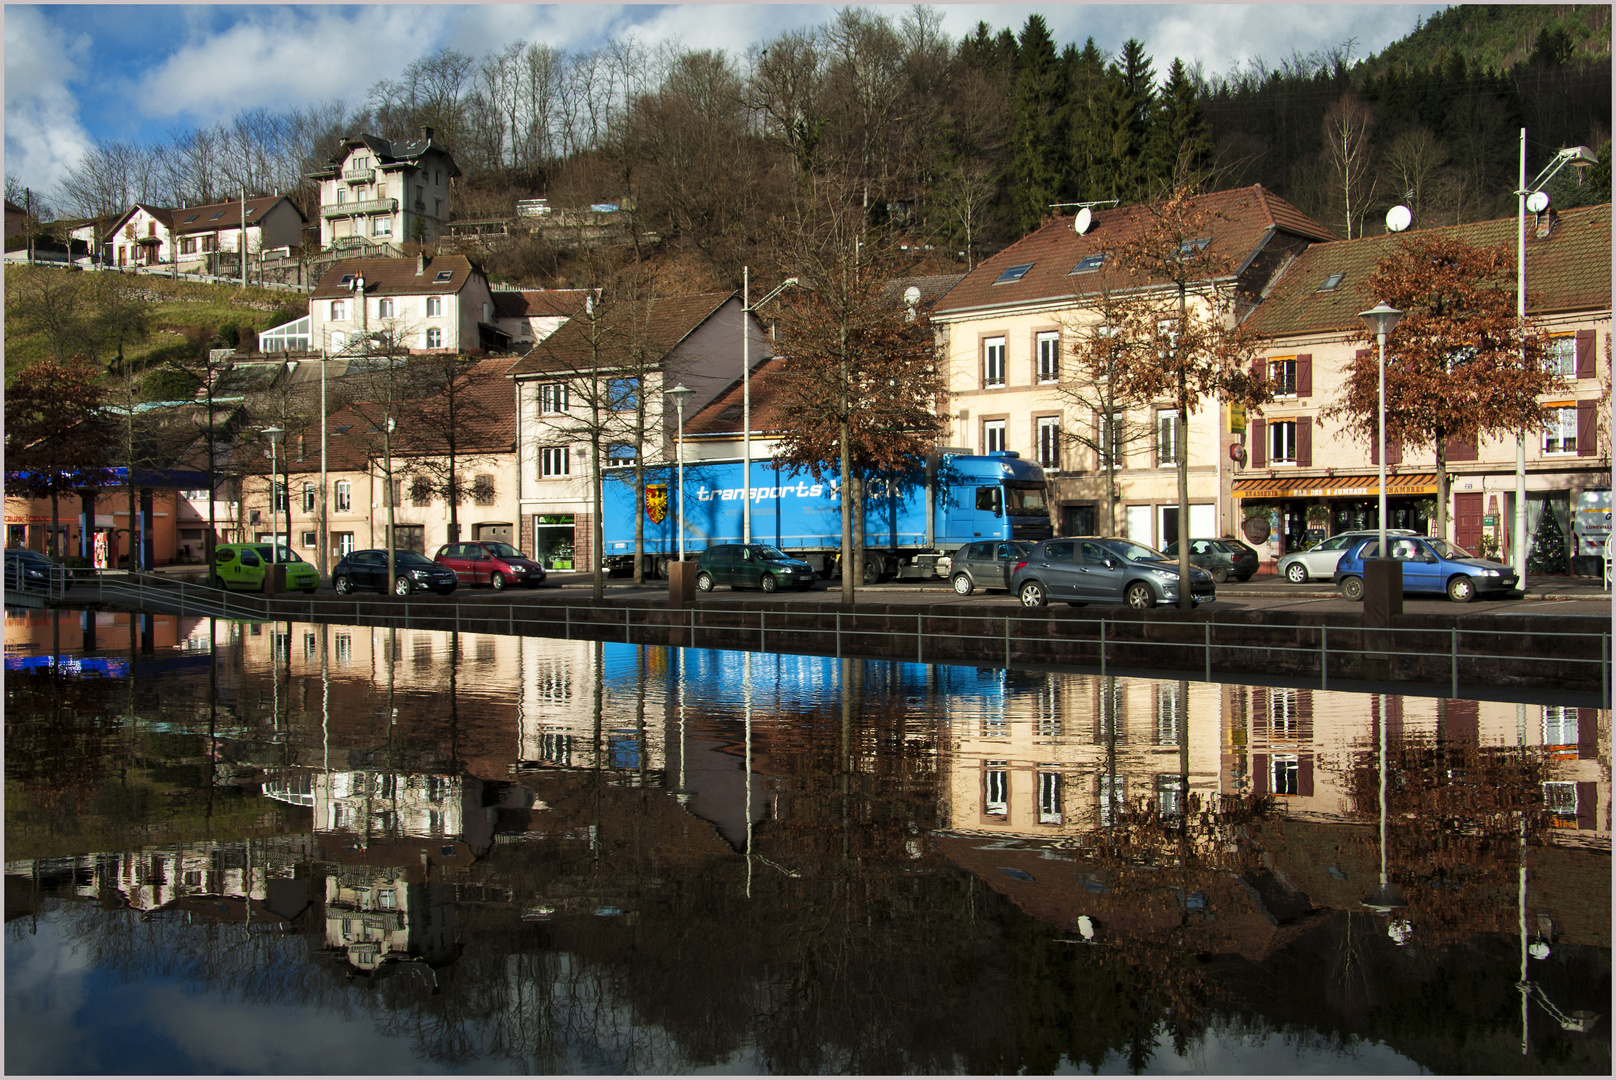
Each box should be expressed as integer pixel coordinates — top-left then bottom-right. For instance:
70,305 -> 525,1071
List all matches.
1010,537 -> 1217,610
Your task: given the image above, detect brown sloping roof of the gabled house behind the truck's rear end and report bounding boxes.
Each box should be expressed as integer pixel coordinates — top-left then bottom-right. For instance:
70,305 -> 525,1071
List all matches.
511,293 -> 735,375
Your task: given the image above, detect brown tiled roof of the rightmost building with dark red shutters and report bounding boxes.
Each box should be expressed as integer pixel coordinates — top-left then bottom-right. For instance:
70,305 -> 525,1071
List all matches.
1251,202 -> 1611,336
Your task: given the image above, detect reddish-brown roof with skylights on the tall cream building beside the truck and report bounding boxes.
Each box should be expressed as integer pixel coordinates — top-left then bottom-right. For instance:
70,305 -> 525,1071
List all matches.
934,184 -> 1336,315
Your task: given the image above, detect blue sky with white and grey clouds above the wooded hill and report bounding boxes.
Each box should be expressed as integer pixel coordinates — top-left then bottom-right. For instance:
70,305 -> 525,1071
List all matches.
5,3 -> 1443,194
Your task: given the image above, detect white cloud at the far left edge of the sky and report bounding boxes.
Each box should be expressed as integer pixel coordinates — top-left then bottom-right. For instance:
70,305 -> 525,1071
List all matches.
5,6 -> 92,191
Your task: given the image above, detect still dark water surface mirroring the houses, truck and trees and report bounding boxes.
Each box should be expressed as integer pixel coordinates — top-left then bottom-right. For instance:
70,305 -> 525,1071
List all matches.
5,613 -> 1610,1074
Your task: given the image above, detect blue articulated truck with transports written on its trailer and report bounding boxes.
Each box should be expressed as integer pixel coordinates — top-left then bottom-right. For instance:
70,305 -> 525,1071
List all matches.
604,451 -> 1055,582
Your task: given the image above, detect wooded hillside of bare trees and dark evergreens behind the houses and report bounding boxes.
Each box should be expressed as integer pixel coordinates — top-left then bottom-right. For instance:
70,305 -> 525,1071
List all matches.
18,5 -> 1611,288
